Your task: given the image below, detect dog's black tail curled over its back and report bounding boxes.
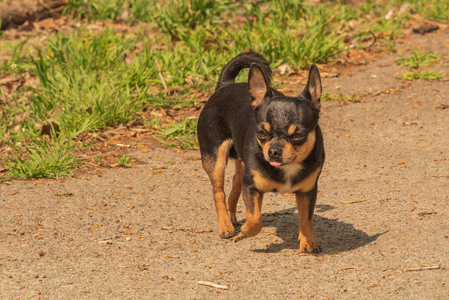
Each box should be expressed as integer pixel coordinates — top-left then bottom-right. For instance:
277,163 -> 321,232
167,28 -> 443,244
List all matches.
215,52 -> 271,90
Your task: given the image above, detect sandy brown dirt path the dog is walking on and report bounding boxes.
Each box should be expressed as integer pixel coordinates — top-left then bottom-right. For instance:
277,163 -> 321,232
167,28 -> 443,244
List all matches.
0,23 -> 449,299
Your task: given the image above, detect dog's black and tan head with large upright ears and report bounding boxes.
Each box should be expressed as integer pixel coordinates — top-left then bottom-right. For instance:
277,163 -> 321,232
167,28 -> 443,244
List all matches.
248,64 -> 322,168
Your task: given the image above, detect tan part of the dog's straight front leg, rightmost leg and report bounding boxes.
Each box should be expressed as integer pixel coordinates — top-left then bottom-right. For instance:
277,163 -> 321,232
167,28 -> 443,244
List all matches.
296,193 -> 321,253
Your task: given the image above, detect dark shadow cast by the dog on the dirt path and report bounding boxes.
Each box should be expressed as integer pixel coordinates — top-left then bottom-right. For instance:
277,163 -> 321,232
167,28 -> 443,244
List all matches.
247,205 -> 386,254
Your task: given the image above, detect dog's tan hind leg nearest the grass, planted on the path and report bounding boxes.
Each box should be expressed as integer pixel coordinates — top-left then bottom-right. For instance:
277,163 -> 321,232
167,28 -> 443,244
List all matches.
203,139 -> 234,238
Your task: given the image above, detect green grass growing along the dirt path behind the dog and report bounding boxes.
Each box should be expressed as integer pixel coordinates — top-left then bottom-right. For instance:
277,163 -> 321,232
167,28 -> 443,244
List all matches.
0,0 -> 448,179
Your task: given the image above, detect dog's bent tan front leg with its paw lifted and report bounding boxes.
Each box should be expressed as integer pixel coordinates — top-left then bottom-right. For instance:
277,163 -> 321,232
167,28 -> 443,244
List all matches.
232,187 -> 263,242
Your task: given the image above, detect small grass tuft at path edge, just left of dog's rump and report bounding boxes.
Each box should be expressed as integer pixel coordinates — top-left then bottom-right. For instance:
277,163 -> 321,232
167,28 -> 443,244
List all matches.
161,118 -> 198,149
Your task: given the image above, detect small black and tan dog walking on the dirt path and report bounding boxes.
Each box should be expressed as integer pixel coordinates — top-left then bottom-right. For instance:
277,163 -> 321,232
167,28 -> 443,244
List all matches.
197,52 -> 325,253
